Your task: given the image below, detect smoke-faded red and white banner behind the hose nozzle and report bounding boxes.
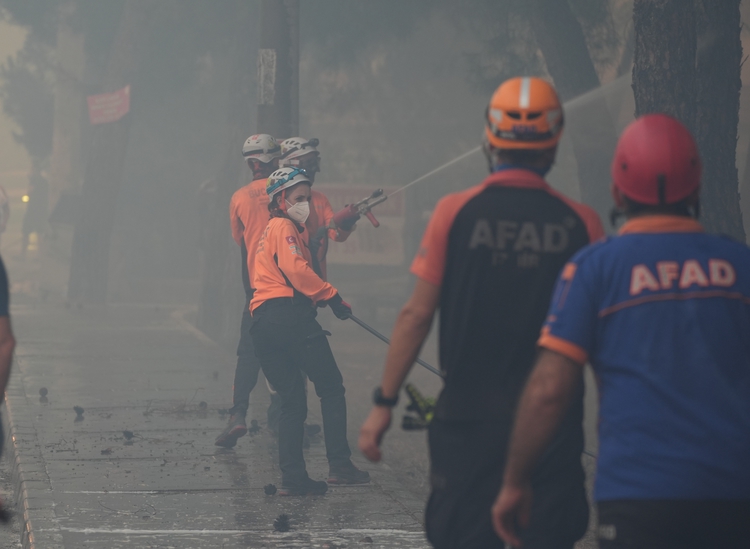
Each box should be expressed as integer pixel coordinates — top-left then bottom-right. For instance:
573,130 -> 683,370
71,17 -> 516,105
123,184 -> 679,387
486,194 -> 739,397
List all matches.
314,183 -> 405,265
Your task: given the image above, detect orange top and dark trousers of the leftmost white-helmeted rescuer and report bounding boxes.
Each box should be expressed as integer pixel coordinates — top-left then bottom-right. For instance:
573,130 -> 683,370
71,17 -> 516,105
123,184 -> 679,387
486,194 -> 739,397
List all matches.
229,178 -> 269,416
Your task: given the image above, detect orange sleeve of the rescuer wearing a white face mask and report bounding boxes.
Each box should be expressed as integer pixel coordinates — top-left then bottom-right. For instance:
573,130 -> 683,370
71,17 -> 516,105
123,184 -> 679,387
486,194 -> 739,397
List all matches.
269,220 -> 338,303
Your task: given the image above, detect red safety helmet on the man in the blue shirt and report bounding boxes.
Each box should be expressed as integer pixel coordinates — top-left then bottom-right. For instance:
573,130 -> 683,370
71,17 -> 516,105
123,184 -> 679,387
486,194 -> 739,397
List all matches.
612,114 -> 701,206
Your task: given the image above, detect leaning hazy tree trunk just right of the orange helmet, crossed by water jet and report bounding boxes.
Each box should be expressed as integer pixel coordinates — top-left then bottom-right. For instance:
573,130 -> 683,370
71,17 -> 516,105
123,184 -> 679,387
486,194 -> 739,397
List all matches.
528,0 -> 617,225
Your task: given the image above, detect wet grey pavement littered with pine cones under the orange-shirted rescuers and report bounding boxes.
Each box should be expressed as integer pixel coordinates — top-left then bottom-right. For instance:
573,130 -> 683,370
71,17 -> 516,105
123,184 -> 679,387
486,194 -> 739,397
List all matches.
3,303 -> 428,549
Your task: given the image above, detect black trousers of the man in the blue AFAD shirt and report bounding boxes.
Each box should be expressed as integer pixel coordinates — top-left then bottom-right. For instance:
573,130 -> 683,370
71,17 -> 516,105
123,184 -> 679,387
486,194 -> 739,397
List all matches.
597,499 -> 750,549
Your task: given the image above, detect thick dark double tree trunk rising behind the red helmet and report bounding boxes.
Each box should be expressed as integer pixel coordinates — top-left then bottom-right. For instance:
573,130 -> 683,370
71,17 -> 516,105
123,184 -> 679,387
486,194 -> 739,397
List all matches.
633,0 -> 745,242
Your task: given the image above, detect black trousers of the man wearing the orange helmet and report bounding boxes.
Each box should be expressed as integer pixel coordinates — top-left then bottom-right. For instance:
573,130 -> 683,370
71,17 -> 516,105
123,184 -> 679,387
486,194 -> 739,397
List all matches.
425,419 -> 589,549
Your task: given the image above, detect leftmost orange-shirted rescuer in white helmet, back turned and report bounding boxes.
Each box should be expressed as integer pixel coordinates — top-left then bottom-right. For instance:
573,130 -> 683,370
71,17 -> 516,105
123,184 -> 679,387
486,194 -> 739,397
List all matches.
214,133 -> 281,448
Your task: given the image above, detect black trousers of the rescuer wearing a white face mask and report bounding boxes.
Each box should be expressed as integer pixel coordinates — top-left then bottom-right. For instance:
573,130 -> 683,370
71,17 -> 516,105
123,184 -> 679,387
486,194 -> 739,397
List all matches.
251,298 -> 351,484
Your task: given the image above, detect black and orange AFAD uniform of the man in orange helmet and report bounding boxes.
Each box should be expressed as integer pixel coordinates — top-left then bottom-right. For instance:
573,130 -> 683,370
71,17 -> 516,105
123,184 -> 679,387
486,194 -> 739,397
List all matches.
411,168 -> 603,549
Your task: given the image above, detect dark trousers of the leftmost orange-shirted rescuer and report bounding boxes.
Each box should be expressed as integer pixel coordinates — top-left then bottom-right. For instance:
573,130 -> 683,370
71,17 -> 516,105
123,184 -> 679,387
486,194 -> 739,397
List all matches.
230,294 -> 281,424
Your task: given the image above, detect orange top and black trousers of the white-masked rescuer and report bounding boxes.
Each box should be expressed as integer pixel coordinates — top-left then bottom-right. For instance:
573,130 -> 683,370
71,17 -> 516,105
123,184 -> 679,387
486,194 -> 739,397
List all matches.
250,217 -> 351,486
